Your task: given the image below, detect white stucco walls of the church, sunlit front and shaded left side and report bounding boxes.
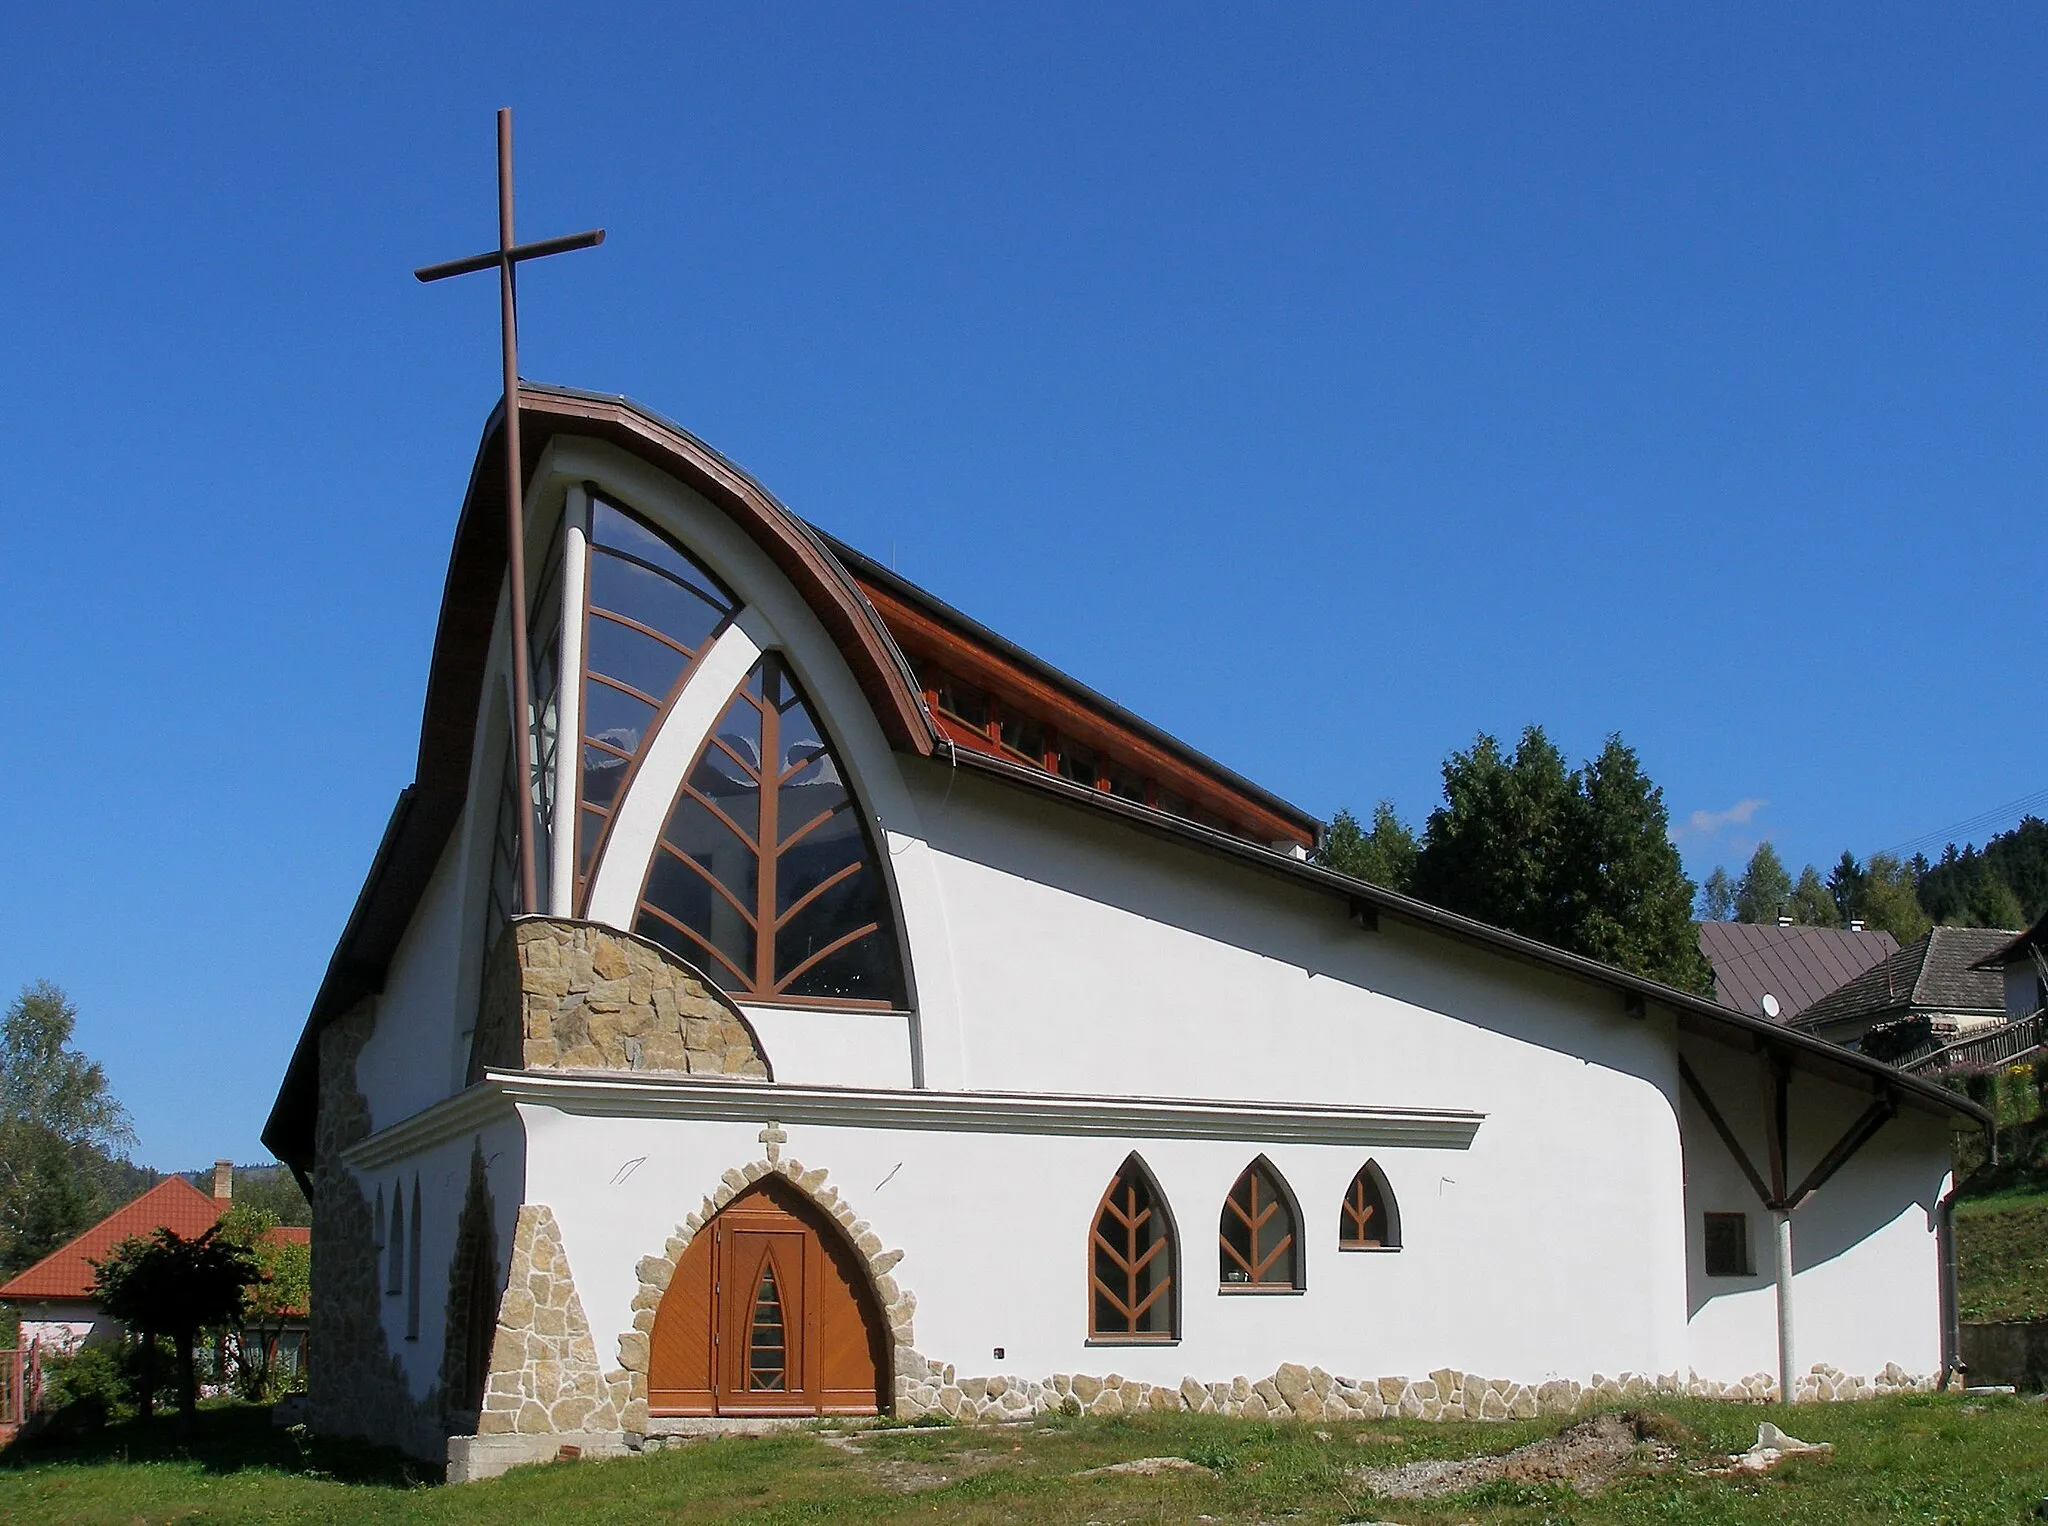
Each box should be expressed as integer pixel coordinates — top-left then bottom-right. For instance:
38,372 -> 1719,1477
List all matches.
335,428 -> 1948,1393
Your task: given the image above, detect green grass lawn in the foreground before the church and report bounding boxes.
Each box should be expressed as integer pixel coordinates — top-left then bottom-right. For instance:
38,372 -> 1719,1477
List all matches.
0,1395 -> 2048,1526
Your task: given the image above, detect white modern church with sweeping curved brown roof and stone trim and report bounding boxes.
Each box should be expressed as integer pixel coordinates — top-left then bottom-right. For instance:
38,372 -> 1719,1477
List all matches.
264,383 -> 1982,1477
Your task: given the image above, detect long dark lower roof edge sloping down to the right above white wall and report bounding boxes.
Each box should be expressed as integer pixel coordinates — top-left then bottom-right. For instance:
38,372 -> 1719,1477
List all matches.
948,748 -> 1991,1129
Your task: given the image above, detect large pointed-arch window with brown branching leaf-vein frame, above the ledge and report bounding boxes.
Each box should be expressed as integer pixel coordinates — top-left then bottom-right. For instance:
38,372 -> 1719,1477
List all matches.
635,653 -> 903,1008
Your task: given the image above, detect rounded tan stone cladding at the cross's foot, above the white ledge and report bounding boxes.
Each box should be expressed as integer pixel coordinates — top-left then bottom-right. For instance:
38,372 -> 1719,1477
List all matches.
469,918 -> 772,1082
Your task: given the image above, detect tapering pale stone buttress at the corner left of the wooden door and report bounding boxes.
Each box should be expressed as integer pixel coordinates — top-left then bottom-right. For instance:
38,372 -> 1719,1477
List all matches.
477,1202 -> 631,1436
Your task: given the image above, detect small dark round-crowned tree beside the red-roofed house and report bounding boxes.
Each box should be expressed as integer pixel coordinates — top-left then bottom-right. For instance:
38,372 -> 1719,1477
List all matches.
92,1225 -> 260,1432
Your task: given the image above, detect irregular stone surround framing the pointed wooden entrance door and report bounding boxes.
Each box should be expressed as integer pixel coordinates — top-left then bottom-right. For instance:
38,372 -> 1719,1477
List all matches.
614,1122 -> 932,1434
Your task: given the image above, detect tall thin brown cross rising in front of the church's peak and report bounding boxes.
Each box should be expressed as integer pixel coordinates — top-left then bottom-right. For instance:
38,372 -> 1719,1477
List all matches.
414,107 -> 604,914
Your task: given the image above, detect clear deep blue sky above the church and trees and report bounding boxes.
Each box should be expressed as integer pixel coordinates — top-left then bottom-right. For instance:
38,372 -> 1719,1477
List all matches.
0,4 -> 2048,1168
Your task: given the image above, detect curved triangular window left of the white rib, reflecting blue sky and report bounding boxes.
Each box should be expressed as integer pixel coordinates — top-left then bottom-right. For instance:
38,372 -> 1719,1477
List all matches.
575,498 -> 739,895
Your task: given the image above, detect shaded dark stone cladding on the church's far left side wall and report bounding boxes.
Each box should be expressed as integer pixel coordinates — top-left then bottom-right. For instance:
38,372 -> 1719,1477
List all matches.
307,998 -> 446,1463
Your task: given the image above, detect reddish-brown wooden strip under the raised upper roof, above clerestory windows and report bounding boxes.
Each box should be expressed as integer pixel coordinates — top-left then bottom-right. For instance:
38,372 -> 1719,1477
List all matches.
856,574 -> 1315,848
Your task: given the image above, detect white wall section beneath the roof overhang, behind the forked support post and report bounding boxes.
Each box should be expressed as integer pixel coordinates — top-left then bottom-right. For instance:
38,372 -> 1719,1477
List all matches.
1683,1038 -> 1950,1383
